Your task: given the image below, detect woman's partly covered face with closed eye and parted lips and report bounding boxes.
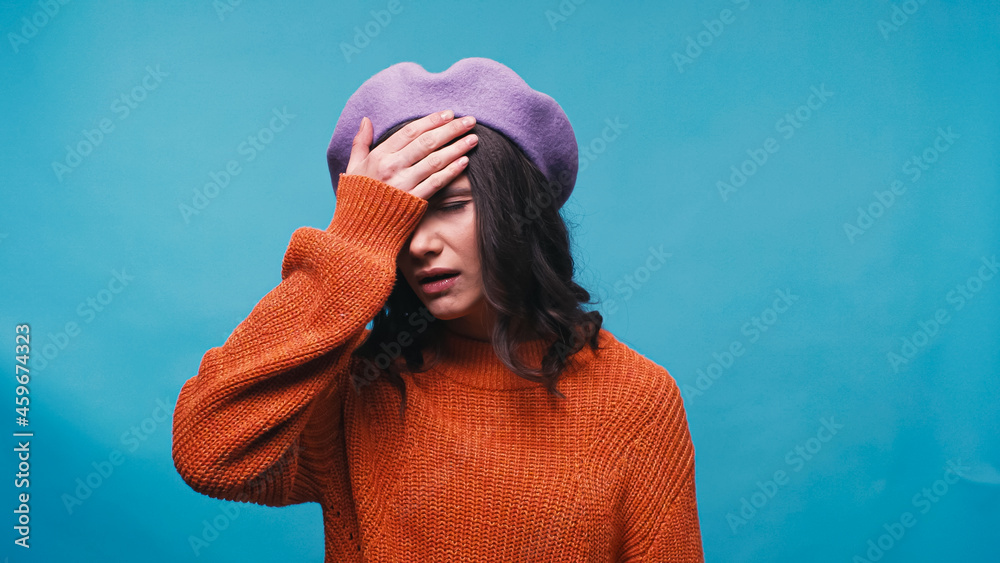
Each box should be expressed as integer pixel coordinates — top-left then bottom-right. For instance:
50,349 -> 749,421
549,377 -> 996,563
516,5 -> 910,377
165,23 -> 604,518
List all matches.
396,173 -> 492,340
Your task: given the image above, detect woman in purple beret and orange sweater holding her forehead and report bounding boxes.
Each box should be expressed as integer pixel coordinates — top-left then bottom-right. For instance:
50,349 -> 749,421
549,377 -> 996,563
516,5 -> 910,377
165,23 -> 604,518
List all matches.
173,58 -> 703,562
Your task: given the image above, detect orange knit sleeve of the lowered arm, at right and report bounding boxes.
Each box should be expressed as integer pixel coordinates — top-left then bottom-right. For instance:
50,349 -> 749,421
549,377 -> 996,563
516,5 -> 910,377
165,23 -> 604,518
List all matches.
622,373 -> 705,563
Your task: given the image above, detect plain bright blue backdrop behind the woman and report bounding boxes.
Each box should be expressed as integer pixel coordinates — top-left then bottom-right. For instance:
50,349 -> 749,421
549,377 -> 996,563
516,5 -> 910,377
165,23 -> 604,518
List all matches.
0,0 -> 1000,562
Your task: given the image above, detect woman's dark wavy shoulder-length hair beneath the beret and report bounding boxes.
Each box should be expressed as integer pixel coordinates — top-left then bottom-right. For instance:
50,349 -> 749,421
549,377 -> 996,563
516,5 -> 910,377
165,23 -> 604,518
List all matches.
353,119 -> 603,416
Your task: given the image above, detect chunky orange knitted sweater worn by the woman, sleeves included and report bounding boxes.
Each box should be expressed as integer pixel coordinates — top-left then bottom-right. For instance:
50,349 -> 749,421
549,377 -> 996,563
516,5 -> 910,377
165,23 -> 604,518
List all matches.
173,174 -> 703,563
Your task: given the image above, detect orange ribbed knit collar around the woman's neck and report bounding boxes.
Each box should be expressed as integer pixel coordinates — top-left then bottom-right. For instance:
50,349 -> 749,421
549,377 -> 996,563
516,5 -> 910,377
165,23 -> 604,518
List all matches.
434,329 -> 564,390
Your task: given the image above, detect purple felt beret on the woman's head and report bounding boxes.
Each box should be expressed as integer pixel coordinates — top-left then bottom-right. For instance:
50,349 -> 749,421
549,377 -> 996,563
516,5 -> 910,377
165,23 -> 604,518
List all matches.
326,57 -> 579,208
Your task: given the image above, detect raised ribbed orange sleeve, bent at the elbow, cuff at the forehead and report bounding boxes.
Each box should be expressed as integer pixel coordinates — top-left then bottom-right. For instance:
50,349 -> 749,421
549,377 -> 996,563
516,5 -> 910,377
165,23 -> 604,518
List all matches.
172,174 -> 428,506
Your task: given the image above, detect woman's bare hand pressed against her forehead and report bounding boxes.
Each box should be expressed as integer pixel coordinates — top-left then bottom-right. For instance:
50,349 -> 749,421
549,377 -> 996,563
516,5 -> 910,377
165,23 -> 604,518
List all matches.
347,110 -> 479,199
